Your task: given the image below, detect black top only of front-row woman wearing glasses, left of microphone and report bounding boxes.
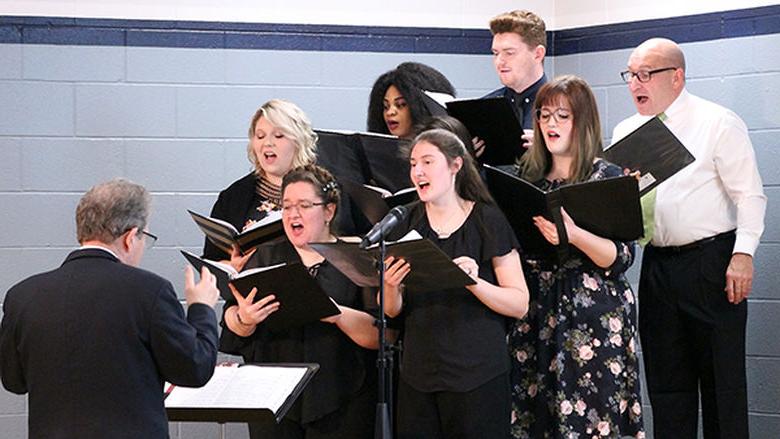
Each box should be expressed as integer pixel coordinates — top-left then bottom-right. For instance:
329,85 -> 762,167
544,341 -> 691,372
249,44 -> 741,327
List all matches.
220,240 -> 377,424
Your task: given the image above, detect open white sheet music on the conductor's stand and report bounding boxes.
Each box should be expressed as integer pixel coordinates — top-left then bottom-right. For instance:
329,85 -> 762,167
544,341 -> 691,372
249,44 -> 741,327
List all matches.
165,365 -> 306,413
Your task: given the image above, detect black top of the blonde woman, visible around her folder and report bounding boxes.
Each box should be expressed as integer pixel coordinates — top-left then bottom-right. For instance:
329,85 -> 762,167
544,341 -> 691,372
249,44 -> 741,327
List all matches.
203,172 -> 276,261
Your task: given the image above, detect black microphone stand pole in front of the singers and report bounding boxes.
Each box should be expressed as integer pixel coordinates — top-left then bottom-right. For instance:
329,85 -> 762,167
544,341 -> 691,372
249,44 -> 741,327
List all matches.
374,236 -> 393,439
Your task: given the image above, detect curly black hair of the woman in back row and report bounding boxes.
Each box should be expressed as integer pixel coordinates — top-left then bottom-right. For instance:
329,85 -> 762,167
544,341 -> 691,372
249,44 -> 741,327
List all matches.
366,62 -> 455,134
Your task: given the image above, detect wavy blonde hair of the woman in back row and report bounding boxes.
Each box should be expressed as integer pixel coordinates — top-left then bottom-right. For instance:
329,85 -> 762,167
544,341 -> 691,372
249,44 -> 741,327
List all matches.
246,99 -> 317,175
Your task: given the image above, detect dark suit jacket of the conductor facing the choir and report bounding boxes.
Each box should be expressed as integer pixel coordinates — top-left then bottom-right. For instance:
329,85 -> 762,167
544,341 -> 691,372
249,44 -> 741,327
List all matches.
0,248 -> 217,438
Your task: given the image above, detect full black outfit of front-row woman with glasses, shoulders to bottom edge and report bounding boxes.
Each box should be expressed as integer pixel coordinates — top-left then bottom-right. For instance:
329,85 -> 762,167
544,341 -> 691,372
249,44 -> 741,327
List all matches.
220,240 -> 377,439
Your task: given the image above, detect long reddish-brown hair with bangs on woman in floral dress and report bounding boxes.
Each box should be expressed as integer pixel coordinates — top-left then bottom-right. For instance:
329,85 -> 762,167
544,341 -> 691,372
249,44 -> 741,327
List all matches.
518,75 -> 603,183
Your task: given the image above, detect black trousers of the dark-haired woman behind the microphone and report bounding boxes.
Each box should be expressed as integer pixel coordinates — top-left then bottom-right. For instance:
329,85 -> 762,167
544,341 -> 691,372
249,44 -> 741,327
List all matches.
397,372 -> 511,439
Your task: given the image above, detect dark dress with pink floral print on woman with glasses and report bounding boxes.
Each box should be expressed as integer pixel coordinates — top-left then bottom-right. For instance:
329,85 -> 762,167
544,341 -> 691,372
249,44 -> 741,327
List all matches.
509,160 -> 644,439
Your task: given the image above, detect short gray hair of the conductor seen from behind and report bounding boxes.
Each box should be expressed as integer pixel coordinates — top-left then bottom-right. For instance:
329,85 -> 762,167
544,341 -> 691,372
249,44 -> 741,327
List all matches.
76,178 -> 151,243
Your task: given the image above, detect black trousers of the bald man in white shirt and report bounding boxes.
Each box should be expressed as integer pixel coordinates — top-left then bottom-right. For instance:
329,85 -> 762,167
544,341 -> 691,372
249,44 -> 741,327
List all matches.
639,233 -> 748,439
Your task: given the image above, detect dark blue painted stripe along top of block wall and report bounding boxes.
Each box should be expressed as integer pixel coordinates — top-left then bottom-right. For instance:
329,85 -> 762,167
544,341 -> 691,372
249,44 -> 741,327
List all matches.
0,5 -> 780,56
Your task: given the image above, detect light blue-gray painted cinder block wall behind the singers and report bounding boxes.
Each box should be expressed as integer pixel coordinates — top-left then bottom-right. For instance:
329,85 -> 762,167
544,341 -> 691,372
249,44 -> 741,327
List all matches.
0,9 -> 780,439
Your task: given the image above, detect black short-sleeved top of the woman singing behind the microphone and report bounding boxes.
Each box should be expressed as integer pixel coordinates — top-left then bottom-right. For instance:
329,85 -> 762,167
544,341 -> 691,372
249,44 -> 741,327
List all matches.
388,203 -> 518,392
